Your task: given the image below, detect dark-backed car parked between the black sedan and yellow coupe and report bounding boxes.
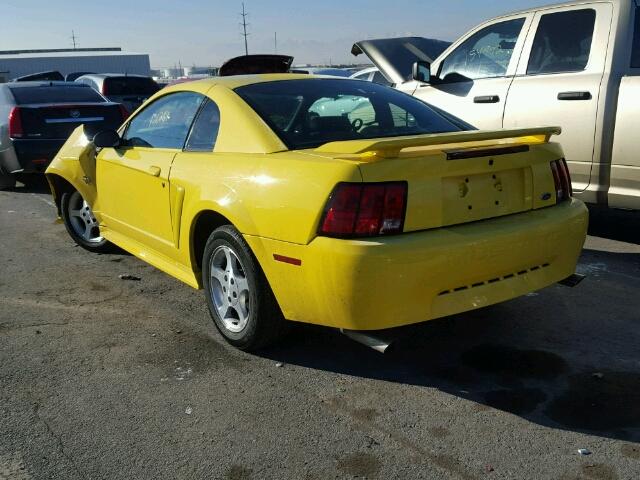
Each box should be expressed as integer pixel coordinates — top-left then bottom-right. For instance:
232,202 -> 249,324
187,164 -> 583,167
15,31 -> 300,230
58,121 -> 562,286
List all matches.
75,73 -> 160,113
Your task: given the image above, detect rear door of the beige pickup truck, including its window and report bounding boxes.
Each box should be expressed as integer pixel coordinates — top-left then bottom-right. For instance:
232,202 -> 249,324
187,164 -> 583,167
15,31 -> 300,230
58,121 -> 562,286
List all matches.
504,2 -> 613,191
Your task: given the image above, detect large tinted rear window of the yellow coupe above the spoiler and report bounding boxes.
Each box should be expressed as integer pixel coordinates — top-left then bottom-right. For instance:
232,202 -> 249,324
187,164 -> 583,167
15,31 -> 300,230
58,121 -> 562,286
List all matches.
235,79 -> 468,150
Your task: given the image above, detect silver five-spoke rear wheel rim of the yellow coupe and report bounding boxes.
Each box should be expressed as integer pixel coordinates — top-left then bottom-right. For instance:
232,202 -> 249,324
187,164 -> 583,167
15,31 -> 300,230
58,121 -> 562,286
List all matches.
209,245 -> 250,333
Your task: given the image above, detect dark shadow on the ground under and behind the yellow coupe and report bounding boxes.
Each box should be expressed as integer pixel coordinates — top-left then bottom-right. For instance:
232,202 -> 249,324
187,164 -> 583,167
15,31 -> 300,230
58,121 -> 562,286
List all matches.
255,246 -> 640,442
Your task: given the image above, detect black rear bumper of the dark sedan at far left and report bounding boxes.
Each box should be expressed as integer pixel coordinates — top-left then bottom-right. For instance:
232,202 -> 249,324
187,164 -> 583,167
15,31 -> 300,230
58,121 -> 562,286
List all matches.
0,139 -> 65,173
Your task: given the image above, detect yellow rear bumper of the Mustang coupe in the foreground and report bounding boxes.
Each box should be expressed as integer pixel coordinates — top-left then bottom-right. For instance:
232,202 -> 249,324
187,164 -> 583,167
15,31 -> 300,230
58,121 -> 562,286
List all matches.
245,200 -> 588,330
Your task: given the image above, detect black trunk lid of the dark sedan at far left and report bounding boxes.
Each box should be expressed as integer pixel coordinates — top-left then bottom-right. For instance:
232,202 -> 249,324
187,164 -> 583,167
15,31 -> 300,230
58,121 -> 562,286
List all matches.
19,102 -> 123,139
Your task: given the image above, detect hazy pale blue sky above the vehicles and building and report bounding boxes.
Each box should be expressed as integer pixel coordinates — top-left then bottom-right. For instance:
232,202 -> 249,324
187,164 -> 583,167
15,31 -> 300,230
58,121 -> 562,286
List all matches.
5,0 -> 550,68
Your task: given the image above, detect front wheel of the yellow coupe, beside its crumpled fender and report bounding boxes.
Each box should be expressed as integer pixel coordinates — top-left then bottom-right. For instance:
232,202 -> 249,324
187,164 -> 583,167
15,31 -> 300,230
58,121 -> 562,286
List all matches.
60,190 -> 111,253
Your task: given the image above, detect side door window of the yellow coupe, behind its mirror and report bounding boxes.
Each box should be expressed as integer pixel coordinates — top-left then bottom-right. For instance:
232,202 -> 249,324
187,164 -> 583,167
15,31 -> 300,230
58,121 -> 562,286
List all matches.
124,92 -> 203,149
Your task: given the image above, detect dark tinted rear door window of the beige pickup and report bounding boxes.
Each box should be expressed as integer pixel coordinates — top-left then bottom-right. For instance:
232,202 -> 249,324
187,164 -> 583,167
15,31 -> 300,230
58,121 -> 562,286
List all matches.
527,9 -> 596,75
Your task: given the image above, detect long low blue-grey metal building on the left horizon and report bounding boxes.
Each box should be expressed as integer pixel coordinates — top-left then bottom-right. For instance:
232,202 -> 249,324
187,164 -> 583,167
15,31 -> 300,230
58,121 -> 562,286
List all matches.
0,48 -> 151,82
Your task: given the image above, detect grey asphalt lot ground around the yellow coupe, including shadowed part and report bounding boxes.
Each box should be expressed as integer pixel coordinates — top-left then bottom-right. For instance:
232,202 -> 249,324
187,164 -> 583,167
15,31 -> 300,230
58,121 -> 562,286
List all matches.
0,186 -> 640,480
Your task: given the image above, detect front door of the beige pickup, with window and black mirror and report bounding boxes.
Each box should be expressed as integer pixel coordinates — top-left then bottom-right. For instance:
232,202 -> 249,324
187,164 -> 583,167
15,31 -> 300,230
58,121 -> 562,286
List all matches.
413,14 -> 532,129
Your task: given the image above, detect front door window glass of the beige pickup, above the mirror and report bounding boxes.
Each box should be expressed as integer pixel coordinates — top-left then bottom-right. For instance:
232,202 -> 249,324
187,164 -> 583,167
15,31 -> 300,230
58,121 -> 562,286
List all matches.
438,18 -> 525,82
